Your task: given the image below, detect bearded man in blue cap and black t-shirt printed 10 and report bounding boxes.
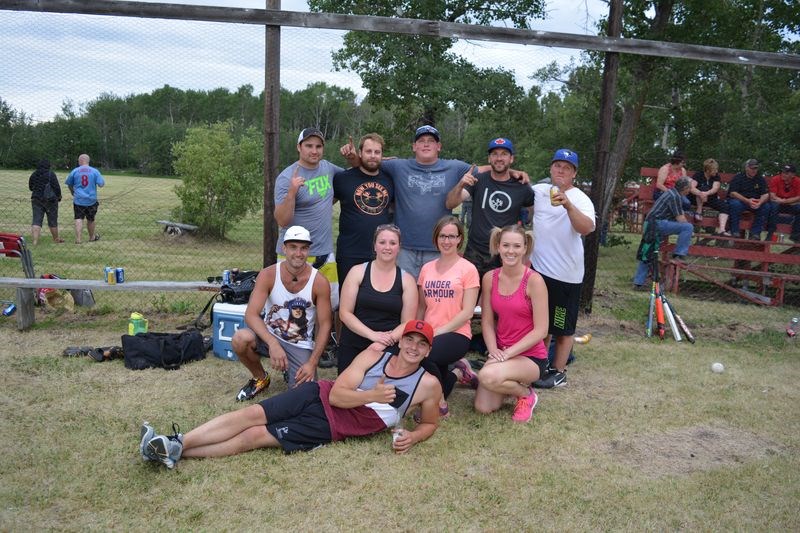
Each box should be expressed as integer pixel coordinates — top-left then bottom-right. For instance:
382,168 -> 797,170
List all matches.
445,137 -> 533,279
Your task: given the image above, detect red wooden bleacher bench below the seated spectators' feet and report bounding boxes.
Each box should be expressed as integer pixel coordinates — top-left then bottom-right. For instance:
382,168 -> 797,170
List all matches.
659,234 -> 800,306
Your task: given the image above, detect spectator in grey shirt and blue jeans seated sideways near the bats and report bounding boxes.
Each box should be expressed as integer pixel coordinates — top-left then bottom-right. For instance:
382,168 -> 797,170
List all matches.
633,176 -> 694,290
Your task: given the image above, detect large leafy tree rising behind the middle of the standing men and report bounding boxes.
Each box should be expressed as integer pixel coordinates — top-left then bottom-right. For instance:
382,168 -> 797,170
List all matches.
309,0 -> 544,132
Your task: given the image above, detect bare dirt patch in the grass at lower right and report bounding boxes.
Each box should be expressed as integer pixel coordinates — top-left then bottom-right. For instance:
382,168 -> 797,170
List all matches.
604,426 -> 784,478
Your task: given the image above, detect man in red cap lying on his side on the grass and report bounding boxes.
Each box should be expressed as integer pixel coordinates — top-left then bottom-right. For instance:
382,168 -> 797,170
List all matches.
140,320 -> 442,468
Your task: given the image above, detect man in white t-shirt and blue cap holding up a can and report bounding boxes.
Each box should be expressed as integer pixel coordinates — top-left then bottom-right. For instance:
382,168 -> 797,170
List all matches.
531,148 -> 595,388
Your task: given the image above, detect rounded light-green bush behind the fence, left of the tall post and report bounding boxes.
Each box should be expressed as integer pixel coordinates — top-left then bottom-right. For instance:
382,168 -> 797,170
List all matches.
172,121 -> 264,238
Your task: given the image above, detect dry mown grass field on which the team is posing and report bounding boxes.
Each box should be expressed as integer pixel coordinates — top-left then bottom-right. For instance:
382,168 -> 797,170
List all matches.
0,168 -> 800,531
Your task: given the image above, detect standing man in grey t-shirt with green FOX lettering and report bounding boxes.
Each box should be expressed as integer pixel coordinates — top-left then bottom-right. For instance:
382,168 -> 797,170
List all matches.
274,128 -> 343,309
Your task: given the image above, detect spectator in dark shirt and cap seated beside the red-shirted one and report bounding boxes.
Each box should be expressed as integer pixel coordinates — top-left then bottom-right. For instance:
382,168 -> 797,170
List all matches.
728,159 -> 769,241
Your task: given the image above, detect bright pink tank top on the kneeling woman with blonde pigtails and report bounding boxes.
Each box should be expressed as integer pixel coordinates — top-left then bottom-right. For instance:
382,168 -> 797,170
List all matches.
491,268 -> 547,359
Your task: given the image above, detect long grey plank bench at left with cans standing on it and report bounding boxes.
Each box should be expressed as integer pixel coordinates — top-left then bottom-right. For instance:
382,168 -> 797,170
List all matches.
0,277 -> 220,331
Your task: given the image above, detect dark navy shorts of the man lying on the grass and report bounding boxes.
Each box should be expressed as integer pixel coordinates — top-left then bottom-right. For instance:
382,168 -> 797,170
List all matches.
259,383 -> 333,453
